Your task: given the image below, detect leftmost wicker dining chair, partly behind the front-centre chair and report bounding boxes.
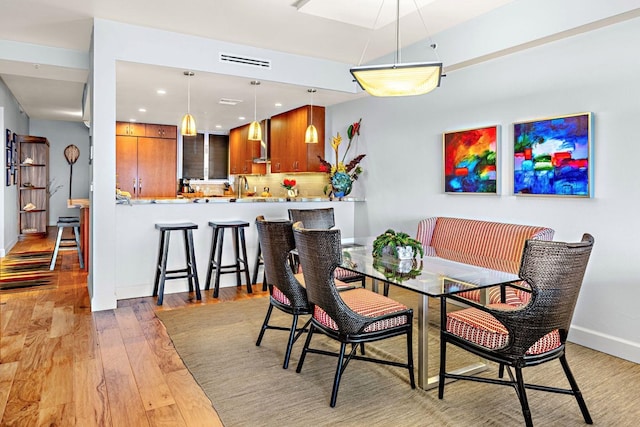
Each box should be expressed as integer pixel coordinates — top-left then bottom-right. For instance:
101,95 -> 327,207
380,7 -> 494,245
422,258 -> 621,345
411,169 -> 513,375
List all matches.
256,216 -> 312,369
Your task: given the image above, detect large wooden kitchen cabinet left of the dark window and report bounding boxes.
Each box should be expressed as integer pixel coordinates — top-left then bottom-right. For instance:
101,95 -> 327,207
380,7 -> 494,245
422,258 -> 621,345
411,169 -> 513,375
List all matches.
116,124 -> 178,198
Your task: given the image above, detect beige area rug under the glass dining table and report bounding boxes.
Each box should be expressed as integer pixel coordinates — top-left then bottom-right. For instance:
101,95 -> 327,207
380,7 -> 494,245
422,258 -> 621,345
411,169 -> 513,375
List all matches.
157,289 -> 640,427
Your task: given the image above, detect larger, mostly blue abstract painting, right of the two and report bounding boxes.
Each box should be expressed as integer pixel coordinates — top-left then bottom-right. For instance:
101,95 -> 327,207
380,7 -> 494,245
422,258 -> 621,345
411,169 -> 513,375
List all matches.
513,113 -> 593,197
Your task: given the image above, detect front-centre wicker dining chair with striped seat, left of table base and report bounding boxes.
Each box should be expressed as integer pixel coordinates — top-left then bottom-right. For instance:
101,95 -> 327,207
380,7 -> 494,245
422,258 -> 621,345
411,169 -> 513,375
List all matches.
294,222 -> 415,407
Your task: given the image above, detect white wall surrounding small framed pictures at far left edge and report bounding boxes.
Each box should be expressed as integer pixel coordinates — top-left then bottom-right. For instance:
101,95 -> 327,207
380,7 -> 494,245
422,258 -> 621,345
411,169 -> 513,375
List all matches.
0,79 -> 29,257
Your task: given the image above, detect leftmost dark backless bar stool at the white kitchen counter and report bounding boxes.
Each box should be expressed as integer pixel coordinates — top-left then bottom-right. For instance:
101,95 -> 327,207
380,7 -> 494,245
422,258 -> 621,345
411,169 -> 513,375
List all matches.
153,222 -> 202,305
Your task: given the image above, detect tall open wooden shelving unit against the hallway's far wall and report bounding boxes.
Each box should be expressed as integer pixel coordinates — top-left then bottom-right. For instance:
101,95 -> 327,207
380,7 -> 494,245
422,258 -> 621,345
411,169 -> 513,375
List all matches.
16,135 -> 49,240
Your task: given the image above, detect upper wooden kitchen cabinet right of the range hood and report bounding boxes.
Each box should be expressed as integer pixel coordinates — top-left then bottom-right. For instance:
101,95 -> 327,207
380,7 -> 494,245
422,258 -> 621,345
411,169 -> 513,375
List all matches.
270,105 -> 325,172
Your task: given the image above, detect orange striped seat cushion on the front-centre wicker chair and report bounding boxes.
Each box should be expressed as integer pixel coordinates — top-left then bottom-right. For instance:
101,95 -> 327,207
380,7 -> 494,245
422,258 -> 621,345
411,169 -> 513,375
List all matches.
313,288 -> 407,332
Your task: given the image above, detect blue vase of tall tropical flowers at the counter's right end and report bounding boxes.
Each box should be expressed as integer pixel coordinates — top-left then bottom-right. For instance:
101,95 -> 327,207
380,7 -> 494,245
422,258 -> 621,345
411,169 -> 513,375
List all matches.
318,119 -> 365,199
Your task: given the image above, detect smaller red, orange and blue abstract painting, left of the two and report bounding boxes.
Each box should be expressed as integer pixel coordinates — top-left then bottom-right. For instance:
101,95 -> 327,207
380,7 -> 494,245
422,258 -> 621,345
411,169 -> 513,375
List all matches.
443,126 -> 498,194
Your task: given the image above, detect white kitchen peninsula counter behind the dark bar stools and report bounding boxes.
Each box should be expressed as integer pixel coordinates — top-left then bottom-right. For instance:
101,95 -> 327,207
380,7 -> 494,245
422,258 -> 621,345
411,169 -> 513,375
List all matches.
114,197 -> 364,300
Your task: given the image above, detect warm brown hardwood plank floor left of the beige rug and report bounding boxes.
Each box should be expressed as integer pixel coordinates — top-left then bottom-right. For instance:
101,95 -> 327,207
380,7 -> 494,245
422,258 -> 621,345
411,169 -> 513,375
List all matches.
0,231 -> 266,426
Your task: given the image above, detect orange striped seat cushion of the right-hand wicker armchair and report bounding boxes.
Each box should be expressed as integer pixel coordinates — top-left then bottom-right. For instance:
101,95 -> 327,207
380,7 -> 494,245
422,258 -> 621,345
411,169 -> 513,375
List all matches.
447,304 -> 561,354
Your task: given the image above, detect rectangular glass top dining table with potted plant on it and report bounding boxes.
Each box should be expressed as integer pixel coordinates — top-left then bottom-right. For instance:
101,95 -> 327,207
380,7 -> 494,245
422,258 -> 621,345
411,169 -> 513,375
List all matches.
341,238 -> 521,389
